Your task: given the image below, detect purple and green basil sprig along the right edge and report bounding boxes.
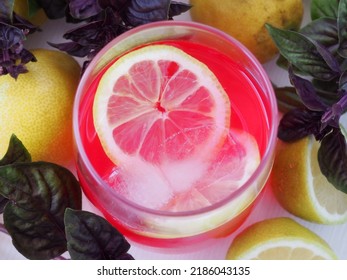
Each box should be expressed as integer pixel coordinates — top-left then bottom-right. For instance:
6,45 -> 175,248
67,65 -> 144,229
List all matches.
267,0 -> 347,193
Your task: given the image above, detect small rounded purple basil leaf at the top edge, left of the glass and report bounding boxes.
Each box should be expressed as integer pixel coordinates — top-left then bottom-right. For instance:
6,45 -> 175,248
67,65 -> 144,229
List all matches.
68,0 -> 102,20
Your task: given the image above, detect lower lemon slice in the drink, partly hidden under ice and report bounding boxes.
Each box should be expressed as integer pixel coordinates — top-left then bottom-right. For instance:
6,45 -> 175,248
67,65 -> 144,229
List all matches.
164,129 -> 260,211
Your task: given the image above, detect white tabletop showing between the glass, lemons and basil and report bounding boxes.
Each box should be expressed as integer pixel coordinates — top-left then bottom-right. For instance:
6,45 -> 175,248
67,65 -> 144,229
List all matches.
0,0 -> 347,260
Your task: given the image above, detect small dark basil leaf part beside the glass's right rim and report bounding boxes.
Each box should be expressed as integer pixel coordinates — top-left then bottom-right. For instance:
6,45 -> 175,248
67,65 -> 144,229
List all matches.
275,87 -> 305,113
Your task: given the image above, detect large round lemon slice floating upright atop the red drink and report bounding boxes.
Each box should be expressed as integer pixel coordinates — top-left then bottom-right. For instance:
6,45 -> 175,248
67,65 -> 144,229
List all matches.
93,45 -> 230,164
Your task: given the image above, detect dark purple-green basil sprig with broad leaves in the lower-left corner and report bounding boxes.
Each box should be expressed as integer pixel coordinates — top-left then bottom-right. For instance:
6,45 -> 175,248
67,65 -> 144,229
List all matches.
0,135 -> 133,259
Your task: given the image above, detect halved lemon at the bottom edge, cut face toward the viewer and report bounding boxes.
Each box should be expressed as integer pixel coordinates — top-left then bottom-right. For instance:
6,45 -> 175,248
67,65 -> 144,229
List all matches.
226,217 -> 337,260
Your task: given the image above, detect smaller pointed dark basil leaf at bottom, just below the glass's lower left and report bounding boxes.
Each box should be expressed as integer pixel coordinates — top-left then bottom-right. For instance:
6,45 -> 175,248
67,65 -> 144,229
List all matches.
65,209 -> 133,260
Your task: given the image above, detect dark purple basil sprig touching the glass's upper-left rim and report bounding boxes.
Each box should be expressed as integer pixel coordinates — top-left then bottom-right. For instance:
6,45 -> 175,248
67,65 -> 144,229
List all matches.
49,0 -> 190,69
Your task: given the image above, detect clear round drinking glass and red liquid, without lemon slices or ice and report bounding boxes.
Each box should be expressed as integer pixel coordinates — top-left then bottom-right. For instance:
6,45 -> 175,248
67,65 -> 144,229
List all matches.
73,20 -> 278,248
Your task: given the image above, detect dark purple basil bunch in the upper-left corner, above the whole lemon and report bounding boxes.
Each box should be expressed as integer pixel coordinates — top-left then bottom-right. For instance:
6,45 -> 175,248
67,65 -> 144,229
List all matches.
0,0 -> 191,78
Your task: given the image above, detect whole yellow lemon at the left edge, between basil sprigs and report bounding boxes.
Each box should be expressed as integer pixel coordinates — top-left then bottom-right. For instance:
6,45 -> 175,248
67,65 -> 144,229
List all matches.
0,49 -> 80,165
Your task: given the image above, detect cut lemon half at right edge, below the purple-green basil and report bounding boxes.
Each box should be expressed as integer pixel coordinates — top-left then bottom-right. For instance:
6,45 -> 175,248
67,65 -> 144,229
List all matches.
271,136 -> 347,224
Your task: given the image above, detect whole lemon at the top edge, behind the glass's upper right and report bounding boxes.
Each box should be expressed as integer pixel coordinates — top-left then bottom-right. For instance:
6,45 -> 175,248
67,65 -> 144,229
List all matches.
190,0 -> 304,63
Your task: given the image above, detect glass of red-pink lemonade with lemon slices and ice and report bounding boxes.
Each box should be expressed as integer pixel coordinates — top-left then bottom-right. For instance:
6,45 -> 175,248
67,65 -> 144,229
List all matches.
74,21 -> 277,247
